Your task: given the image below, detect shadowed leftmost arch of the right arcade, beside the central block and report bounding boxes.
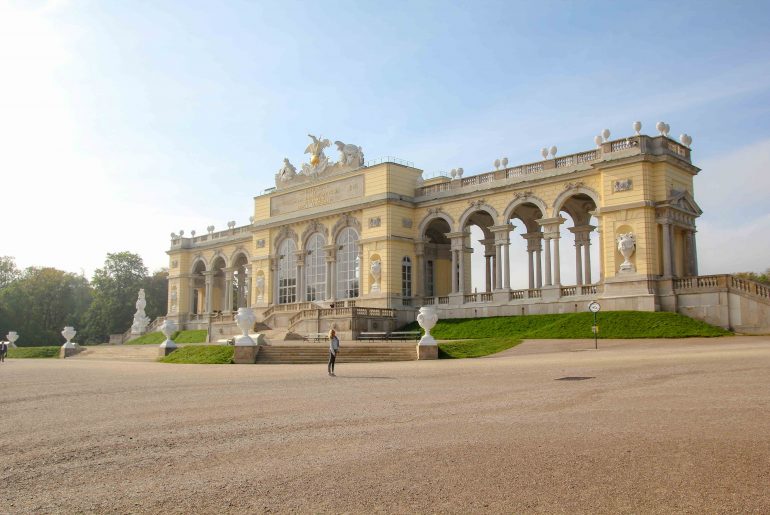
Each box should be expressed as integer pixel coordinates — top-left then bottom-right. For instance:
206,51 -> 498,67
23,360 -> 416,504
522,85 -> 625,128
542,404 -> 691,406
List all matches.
421,218 -> 452,297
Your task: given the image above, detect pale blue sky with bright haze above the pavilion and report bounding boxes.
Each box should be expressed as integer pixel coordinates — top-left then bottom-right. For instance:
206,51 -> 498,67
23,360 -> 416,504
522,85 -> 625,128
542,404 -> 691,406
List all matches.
0,0 -> 770,282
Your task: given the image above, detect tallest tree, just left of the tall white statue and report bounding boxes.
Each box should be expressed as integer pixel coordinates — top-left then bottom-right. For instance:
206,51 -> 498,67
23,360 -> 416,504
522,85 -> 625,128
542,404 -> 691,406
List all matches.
85,252 -> 147,342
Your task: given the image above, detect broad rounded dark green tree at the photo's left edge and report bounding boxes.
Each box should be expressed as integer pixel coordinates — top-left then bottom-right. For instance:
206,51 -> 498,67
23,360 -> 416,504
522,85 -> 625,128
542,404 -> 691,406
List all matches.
0,267 -> 91,345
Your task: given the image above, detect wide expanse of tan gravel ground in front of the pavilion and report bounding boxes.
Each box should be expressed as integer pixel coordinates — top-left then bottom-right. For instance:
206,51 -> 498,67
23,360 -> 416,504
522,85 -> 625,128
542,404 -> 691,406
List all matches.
0,337 -> 770,513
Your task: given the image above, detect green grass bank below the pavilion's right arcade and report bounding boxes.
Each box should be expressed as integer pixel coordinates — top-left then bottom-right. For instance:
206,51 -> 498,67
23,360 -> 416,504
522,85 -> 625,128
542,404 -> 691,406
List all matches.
405,311 -> 731,340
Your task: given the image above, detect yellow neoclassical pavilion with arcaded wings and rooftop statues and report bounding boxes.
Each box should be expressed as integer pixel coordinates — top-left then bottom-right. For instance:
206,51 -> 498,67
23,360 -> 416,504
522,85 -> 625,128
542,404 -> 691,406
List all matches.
168,128 -> 767,339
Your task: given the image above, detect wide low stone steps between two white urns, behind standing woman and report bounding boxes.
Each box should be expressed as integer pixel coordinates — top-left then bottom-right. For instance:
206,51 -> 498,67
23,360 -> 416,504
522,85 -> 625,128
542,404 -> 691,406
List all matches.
257,343 -> 417,365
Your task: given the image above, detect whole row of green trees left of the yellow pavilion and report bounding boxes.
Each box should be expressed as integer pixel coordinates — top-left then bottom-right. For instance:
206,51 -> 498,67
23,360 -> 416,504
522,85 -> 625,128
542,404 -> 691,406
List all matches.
0,252 -> 168,345
